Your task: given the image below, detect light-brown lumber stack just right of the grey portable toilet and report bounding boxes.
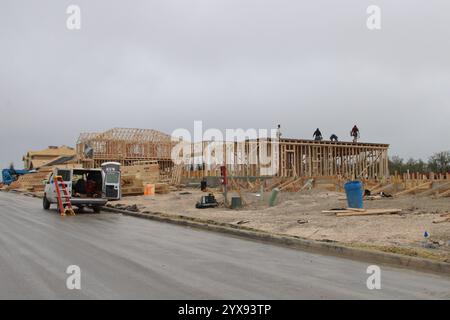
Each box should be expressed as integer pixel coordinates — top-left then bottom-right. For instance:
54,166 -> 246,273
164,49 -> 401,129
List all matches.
121,161 -> 160,196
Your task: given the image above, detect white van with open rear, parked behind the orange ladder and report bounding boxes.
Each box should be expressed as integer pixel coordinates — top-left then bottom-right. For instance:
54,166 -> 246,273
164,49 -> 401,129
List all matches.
43,169 -> 108,212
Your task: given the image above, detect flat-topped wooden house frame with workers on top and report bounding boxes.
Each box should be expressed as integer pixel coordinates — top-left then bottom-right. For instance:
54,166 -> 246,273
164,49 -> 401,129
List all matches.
181,139 -> 389,179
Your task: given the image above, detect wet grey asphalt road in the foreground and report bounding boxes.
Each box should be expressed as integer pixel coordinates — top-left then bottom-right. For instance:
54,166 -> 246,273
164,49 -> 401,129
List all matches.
0,192 -> 450,299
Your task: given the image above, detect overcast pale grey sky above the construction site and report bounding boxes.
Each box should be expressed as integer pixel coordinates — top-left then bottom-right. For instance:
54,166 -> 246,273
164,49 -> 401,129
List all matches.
0,0 -> 450,167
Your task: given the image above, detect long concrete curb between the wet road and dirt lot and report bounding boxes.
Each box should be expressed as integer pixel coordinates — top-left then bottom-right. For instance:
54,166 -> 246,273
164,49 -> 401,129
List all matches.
104,207 -> 450,277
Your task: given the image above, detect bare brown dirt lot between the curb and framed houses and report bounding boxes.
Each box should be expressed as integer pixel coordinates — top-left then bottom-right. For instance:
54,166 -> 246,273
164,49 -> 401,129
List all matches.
111,189 -> 450,262
